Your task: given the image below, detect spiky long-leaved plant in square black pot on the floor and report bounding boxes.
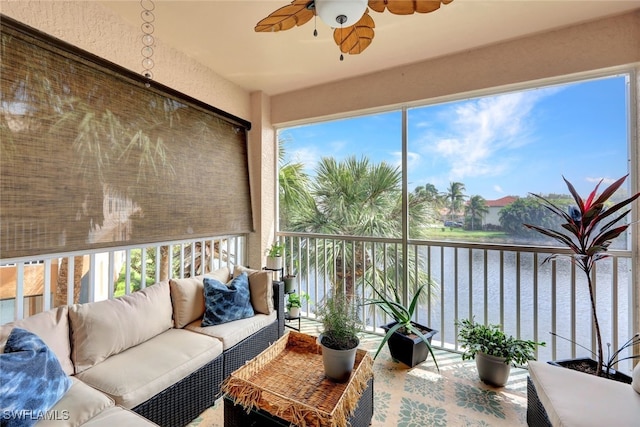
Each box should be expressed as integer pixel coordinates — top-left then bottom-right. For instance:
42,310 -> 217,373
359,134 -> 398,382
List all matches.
366,285 -> 440,370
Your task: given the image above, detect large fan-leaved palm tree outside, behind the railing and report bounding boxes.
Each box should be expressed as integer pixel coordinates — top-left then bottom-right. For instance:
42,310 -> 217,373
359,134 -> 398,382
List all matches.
286,157 -> 432,310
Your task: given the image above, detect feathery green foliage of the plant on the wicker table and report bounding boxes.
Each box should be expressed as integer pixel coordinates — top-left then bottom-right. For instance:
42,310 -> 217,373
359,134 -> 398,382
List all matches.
317,293 -> 362,350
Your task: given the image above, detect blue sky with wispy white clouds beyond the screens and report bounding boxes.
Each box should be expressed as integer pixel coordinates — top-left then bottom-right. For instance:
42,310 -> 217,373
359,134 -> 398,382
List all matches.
279,75 -> 629,200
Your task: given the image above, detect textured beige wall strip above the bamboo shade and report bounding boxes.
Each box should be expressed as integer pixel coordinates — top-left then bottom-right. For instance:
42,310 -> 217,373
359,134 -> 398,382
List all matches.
0,0 -> 251,120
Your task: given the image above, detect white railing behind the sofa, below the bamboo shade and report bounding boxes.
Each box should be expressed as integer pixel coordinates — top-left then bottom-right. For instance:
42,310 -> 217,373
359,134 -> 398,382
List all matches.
0,235 -> 246,324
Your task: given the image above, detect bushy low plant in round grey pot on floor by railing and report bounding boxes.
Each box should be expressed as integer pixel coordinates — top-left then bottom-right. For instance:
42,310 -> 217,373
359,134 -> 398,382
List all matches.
456,319 -> 545,387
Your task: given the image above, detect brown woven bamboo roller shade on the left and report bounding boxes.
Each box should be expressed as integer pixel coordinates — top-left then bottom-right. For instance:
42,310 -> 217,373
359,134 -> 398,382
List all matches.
0,19 -> 252,259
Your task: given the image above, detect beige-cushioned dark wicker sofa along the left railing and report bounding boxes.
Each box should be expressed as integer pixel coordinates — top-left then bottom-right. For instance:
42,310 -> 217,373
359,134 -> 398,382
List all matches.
0,267 -> 284,426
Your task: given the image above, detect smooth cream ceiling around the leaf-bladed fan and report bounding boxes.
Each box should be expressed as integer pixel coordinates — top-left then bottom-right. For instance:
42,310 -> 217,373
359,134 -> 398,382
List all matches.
102,0 -> 640,95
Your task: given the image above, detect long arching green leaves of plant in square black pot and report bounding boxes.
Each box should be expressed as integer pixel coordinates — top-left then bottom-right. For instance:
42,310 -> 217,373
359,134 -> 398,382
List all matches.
365,285 -> 440,371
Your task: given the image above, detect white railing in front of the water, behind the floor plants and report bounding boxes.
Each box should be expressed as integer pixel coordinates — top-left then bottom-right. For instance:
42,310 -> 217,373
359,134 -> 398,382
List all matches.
279,232 -> 637,376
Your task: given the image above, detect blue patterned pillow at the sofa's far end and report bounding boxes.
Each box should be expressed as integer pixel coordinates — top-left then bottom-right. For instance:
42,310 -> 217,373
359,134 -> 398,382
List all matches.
202,273 -> 254,326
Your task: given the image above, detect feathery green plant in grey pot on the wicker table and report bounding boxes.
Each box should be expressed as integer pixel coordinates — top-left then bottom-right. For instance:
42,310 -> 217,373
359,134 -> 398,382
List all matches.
318,293 -> 362,382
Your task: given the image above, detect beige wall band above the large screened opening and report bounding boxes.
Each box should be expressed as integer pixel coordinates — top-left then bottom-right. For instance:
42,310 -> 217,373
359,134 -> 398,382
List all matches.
271,9 -> 640,126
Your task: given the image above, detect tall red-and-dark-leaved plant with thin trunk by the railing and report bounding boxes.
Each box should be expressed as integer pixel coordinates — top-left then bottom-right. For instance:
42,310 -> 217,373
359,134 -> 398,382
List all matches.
523,175 -> 640,376
